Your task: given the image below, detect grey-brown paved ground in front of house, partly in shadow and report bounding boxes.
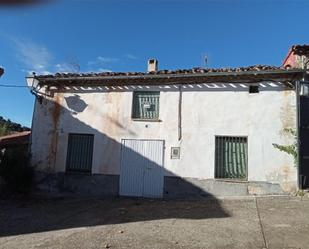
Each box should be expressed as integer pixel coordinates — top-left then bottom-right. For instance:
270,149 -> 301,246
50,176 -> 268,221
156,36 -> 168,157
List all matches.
0,197 -> 309,249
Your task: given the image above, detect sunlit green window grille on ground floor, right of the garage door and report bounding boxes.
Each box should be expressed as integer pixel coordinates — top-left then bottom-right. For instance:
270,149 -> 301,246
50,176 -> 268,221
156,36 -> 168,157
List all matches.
215,136 -> 248,179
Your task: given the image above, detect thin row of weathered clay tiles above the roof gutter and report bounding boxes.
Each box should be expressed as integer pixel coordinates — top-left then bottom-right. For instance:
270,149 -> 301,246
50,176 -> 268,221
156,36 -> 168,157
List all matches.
35,65 -> 284,79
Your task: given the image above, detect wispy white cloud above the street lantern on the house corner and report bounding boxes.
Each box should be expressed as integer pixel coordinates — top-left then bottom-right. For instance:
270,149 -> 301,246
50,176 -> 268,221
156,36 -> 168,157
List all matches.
10,37 -> 53,74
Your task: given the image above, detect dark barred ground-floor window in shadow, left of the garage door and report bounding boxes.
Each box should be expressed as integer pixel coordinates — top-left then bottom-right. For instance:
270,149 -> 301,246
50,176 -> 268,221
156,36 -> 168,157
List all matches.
66,134 -> 94,173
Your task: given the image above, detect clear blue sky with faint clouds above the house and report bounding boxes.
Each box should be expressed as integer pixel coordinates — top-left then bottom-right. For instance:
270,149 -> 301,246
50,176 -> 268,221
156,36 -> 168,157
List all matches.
0,0 -> 309,127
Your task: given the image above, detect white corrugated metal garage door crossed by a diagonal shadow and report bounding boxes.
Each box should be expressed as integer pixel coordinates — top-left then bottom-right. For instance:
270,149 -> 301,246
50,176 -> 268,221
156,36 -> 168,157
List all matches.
119,139 -> 164,197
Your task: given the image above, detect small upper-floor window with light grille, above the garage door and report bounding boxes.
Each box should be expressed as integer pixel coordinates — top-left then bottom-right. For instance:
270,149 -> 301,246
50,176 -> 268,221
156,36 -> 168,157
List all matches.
132,92 -> 160,120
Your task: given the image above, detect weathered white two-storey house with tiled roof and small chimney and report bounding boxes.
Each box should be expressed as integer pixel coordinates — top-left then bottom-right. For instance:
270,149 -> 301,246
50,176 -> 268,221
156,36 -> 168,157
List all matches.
27,47 -> 309,197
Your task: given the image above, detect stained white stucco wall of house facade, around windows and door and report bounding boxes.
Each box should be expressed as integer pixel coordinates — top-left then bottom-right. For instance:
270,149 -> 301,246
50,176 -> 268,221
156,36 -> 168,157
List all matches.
31,82 -> 297,190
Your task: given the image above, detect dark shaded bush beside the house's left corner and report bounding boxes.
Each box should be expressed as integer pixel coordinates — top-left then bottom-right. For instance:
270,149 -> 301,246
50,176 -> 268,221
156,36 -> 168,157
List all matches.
0,147 -> 33,193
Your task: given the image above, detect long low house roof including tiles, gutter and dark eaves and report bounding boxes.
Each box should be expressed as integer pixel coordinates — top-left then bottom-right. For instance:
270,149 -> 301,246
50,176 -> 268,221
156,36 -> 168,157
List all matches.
32,65 -> 304,87
